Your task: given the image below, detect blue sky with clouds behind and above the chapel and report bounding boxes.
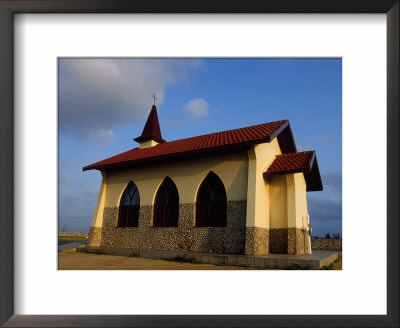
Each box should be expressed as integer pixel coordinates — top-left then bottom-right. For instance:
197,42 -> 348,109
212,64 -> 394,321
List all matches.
59,58 -> 342,236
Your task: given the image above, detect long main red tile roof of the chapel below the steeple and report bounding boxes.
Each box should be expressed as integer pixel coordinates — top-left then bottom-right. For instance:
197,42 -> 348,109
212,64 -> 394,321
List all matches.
83,120 -> 290,171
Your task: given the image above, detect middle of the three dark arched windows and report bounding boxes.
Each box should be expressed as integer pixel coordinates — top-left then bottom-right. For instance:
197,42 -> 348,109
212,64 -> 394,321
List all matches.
153,177 -> 179,227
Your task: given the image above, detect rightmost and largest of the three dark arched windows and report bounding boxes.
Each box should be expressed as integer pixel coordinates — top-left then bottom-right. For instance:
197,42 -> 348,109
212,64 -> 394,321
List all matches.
196,172 -> 226,227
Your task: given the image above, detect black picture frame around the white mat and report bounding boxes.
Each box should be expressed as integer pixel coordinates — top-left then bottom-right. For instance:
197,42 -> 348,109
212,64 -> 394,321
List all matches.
0,0 -> 400,327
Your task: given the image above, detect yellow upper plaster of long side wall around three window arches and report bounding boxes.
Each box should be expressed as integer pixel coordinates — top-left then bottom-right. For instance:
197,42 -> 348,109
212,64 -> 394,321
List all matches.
104,152 -> 247,207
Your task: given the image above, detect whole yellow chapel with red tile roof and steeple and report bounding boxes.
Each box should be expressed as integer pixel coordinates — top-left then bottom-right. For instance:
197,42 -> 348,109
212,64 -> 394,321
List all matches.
83,105 -> 322,255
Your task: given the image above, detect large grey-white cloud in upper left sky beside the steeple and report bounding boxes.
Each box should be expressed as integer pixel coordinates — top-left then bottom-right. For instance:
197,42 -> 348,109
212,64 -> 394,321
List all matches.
59,58 -> 201,142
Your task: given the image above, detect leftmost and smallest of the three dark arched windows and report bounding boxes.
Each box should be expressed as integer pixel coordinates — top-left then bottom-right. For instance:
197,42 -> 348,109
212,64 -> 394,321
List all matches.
117,181 -> 140,227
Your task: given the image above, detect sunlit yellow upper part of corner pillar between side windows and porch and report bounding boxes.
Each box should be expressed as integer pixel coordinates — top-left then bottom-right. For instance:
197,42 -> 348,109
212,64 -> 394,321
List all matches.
246,138 -> 281,228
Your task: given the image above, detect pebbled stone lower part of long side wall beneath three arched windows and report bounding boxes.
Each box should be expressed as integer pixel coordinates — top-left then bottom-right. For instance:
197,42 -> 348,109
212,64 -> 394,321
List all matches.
93,201 -> 247,254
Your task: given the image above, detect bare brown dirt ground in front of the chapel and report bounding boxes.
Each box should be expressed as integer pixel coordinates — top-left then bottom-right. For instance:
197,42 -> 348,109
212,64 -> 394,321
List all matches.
58,248 -> 342,270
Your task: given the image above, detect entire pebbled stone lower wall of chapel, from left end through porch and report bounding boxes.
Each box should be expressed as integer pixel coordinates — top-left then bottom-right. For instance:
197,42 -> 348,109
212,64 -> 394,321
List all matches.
86,201 -> 307,255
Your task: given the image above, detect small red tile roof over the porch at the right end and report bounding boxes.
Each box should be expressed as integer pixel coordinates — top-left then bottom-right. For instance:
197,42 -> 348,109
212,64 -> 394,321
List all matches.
264,150 -> 322,191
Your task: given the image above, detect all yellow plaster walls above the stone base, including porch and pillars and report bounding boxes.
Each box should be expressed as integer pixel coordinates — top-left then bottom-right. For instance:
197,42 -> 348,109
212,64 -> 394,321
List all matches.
92,138 -> 308,229
